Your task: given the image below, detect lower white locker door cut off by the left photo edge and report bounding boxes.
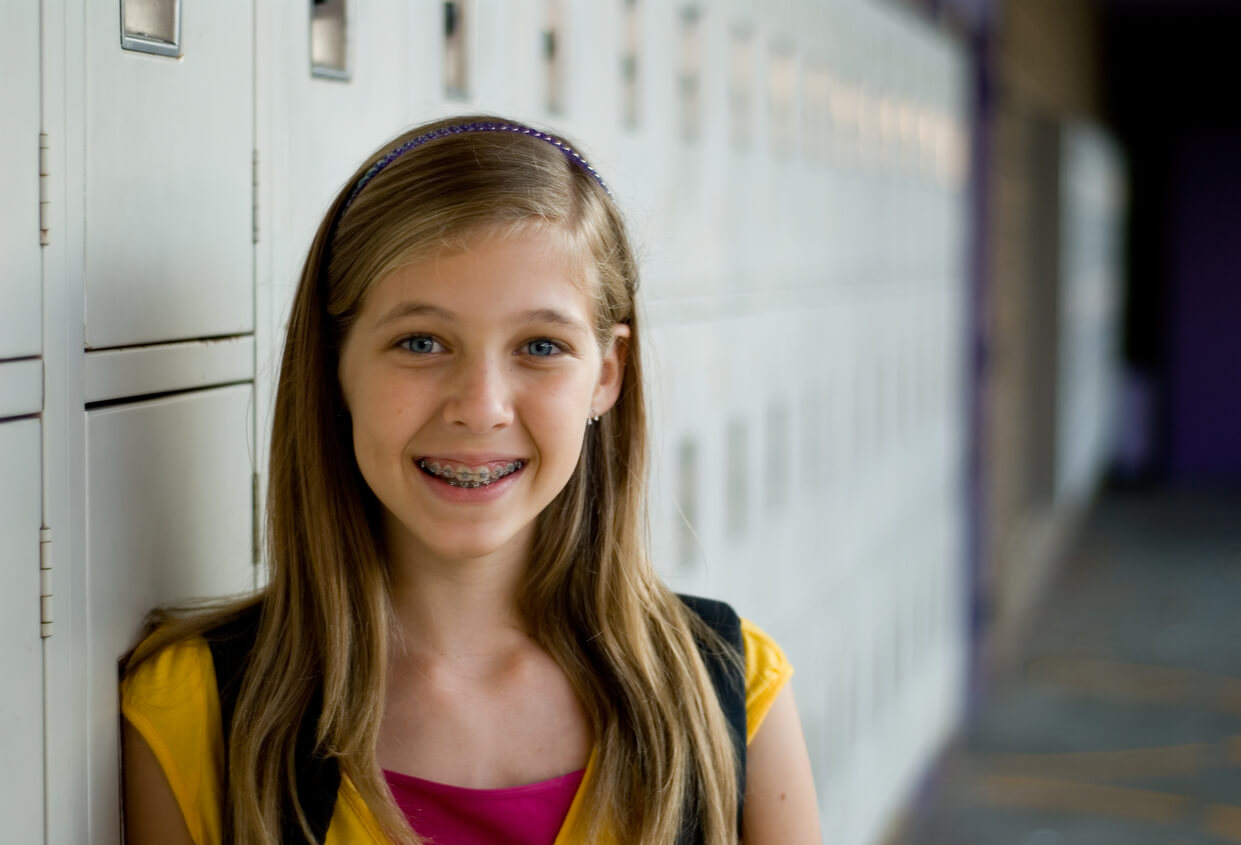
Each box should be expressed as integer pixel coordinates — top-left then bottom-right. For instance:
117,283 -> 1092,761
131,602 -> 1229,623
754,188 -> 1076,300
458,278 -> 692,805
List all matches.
0,419 -> 43,844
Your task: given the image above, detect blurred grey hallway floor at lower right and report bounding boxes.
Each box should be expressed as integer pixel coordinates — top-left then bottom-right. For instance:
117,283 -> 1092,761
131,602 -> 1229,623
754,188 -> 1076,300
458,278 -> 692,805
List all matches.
900,493 -> 1241,845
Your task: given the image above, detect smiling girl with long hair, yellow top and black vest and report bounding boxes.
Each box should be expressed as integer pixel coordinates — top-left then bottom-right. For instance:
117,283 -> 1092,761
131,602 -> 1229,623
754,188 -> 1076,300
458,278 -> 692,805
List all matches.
122,117 -> 819,845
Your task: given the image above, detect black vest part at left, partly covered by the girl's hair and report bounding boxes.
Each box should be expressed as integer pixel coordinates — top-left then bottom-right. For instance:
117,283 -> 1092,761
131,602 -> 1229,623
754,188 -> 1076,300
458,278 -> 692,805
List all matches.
204,604 -> 340,845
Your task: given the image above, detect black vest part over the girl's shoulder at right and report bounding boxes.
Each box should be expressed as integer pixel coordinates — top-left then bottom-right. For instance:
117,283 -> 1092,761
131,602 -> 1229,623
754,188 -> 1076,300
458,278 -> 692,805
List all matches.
678,594 -> 746,845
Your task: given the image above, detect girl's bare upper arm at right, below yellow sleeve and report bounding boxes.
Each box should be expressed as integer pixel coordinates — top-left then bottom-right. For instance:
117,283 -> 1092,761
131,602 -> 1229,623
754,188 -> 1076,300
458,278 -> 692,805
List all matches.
741,686 -> 823,845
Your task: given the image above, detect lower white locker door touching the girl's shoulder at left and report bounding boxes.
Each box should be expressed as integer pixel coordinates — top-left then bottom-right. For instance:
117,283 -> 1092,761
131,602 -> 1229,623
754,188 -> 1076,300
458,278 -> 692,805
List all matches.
86,385 -> 254,843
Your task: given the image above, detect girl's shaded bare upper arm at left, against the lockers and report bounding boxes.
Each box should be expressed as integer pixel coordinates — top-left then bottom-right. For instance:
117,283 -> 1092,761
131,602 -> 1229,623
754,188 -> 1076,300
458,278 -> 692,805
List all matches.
120,720 -> 194,845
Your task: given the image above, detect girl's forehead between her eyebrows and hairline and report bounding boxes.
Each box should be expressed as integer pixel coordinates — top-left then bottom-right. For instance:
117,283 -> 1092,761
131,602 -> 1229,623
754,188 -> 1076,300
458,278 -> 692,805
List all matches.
360,226 -> 597,323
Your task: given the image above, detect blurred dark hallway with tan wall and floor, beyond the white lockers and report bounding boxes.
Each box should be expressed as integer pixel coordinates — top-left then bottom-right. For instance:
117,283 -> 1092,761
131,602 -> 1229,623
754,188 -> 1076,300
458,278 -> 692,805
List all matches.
889,0 -> 1241,845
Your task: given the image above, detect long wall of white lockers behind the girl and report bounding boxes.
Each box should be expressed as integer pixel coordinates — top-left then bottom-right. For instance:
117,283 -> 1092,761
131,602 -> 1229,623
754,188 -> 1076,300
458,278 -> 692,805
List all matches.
0,0 -> 964,845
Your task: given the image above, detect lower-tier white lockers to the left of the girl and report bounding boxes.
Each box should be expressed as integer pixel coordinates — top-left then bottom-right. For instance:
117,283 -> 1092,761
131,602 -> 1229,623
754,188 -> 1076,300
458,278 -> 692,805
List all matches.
0,384 -> 254,843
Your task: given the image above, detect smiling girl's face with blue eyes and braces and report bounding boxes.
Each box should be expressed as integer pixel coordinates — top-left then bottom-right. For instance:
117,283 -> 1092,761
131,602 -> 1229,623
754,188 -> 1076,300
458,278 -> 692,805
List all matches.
338,227 -> 629,561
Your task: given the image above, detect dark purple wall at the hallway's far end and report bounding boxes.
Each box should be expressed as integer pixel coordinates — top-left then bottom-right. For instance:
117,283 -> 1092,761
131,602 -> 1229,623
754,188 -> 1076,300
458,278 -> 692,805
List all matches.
1167,130 -> 1241,484
